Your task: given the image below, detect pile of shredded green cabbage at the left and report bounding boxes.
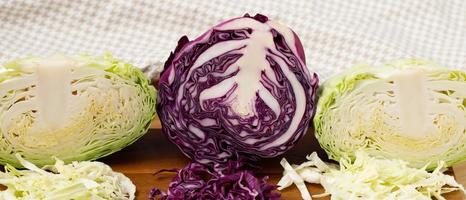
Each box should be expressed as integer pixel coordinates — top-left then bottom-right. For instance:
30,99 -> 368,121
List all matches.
0,154 -> 136,200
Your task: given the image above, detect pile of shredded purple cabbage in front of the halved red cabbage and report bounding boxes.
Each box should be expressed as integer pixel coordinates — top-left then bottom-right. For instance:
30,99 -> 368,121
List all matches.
149,162 -> 280,200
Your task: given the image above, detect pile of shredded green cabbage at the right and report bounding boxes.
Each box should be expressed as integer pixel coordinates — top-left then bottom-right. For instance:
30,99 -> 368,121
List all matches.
278,151 -> 465,200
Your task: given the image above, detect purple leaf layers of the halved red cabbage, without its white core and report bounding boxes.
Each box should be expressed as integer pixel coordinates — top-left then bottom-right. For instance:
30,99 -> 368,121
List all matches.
157,14 -> 318,164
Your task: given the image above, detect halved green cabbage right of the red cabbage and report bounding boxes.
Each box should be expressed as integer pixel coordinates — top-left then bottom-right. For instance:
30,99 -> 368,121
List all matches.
314,60 -> 466,169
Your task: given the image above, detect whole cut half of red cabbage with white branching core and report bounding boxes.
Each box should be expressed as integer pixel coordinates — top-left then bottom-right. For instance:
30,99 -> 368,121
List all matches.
157,14 -> 318,164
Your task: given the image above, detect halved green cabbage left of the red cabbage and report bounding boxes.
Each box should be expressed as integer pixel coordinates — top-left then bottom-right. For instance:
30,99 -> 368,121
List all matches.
0,55 -> 155,167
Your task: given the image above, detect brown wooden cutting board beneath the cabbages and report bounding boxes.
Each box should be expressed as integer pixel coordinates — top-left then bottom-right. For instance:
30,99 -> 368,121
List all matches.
100,122 -> 466,200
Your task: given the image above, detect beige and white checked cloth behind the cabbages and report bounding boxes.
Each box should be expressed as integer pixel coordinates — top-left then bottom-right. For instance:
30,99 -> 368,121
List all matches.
0,0 -> 466,79
